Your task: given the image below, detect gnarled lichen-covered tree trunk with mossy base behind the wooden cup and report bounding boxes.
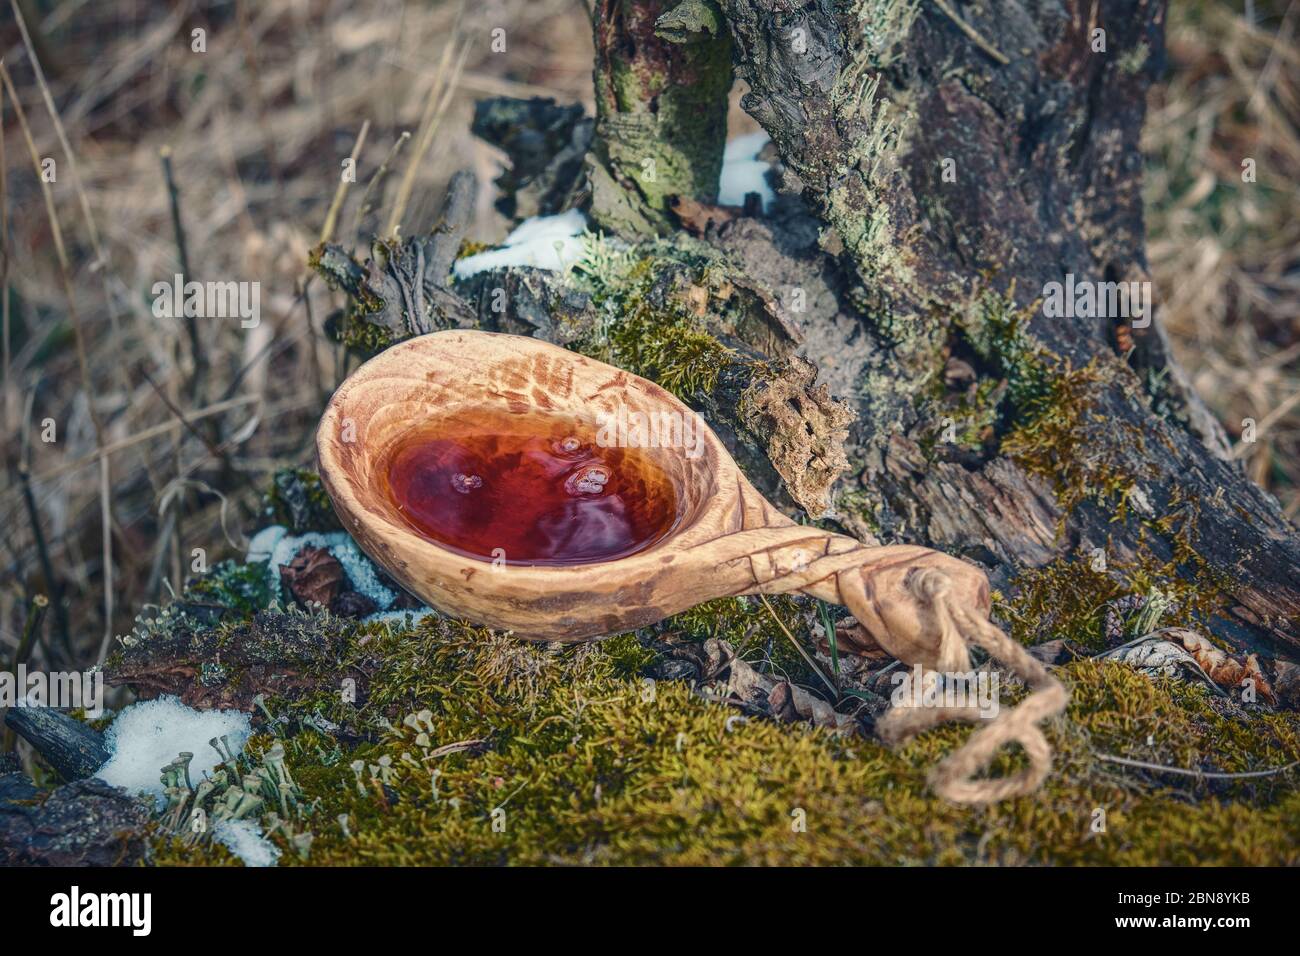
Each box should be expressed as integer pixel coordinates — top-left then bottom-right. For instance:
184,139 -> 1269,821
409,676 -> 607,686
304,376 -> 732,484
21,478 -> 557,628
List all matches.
325,0 -> 1300,658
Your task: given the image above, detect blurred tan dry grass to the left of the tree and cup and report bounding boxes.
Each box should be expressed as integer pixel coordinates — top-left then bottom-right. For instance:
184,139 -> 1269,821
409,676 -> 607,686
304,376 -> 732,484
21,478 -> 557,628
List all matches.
0,0 -> 590,667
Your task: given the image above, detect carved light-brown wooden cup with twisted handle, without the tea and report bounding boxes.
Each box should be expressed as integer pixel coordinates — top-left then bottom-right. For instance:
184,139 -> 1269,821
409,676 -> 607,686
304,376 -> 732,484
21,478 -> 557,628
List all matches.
316,330 -> 988,665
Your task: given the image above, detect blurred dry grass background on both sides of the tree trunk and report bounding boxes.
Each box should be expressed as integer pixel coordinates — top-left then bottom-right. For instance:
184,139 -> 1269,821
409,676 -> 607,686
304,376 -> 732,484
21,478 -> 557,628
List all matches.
0,0 -> 1300,670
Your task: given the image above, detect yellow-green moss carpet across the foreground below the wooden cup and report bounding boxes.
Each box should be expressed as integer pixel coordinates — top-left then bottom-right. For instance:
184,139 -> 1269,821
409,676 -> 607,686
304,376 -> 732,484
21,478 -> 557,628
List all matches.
147,624 -> 1300,865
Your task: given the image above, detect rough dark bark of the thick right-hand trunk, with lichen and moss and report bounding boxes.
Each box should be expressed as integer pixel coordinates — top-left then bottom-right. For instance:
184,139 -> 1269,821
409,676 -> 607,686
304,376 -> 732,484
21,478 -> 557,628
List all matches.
723,0 -> 1300,656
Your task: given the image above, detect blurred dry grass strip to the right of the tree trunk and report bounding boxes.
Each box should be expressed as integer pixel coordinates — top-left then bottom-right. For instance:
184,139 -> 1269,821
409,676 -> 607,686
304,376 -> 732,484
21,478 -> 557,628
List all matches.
1144,0 -> 1300,519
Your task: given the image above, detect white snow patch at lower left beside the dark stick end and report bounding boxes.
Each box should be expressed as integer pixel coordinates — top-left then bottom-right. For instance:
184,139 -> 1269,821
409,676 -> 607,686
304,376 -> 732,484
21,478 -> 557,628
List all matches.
95,696 -> 251,804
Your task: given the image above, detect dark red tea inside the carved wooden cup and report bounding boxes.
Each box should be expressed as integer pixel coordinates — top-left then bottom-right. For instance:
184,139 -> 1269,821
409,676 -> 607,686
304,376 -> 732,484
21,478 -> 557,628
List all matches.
386,410 -> 677,564
